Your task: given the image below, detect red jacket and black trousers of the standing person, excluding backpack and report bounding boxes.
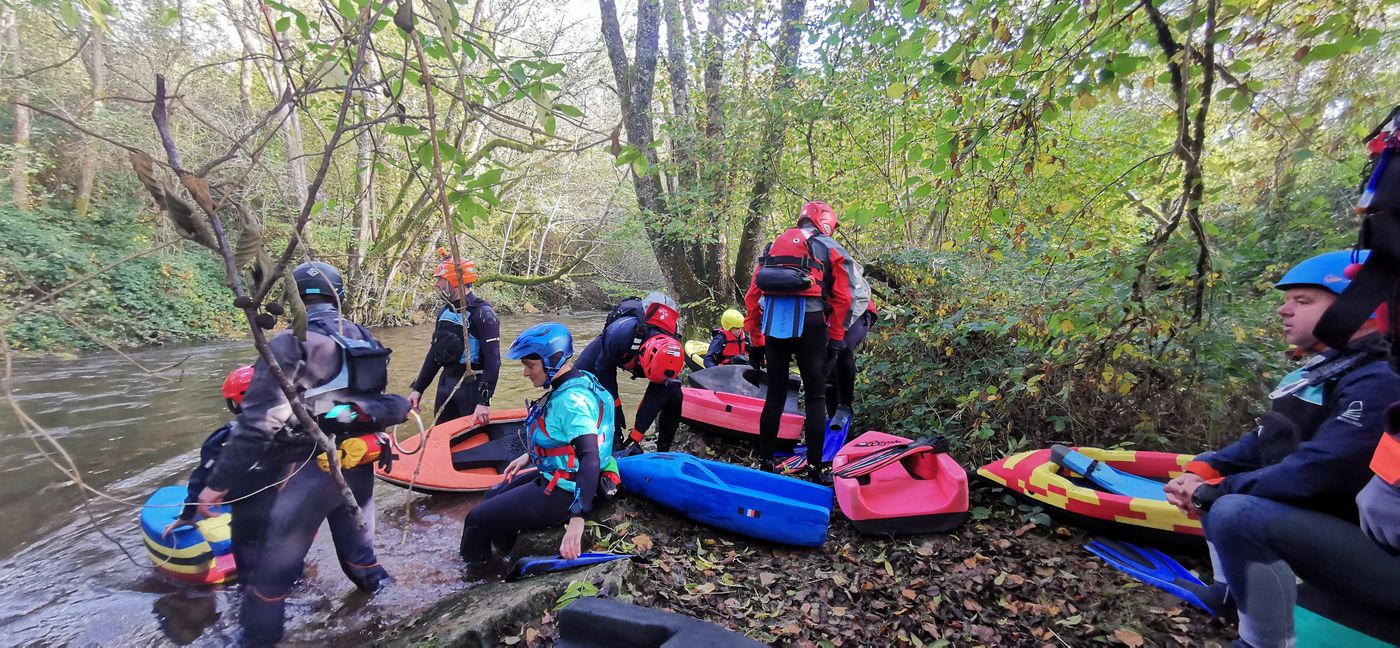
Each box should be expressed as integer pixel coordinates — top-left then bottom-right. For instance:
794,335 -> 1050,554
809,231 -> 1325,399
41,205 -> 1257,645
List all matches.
743,224 -> 854,466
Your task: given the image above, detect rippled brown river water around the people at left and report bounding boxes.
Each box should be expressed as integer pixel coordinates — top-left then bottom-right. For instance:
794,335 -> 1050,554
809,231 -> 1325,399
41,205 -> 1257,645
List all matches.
0,312 -> 645,645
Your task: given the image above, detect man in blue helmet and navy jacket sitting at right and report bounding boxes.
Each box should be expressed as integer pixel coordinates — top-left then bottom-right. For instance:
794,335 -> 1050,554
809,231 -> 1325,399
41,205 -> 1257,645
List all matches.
1165,251 -> 1400,647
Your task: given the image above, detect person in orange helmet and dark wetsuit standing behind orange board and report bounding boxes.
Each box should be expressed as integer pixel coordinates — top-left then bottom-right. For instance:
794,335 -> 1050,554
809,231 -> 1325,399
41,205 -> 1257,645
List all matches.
409,259 -> 501,424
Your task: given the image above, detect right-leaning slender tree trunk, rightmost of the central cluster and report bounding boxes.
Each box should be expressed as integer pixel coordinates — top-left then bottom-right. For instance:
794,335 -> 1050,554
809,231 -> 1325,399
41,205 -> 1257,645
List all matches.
734,0 -> 806,298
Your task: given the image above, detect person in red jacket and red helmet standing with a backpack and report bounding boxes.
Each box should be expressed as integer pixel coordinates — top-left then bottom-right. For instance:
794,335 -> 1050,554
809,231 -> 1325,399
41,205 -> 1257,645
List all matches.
743,202 -> 854,483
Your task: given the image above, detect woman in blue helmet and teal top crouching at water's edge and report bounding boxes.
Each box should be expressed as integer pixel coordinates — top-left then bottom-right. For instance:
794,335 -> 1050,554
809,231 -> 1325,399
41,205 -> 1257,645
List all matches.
461,322 -> 617,570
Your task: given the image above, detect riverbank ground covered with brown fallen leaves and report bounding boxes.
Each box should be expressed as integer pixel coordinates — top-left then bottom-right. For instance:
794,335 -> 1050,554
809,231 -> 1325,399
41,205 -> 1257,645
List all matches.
391,435 -> 1235,647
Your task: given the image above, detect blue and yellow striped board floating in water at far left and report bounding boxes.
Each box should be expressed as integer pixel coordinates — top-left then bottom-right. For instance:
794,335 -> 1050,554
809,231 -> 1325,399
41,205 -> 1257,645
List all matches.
141,486 -> 237,585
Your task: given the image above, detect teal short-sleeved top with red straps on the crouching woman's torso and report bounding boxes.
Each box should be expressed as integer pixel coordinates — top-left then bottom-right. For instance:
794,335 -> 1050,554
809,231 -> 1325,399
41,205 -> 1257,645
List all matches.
525,371 -> 617,498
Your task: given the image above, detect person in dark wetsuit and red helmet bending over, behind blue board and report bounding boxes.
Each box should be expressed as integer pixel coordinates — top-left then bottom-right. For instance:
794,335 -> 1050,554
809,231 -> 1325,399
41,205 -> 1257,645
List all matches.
575,293 -> 685,452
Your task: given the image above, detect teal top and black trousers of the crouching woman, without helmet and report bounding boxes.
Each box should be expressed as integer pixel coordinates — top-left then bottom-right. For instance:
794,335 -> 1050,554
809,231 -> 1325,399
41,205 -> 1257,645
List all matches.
461,369 -> 616,563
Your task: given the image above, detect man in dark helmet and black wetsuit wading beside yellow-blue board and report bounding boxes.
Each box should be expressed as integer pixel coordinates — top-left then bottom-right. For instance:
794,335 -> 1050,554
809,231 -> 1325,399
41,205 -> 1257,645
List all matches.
199,262 -> 409,645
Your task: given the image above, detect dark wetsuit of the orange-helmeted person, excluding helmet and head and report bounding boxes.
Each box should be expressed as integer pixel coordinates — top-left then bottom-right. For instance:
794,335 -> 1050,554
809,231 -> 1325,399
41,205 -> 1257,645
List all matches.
410,294 -> 501,423
